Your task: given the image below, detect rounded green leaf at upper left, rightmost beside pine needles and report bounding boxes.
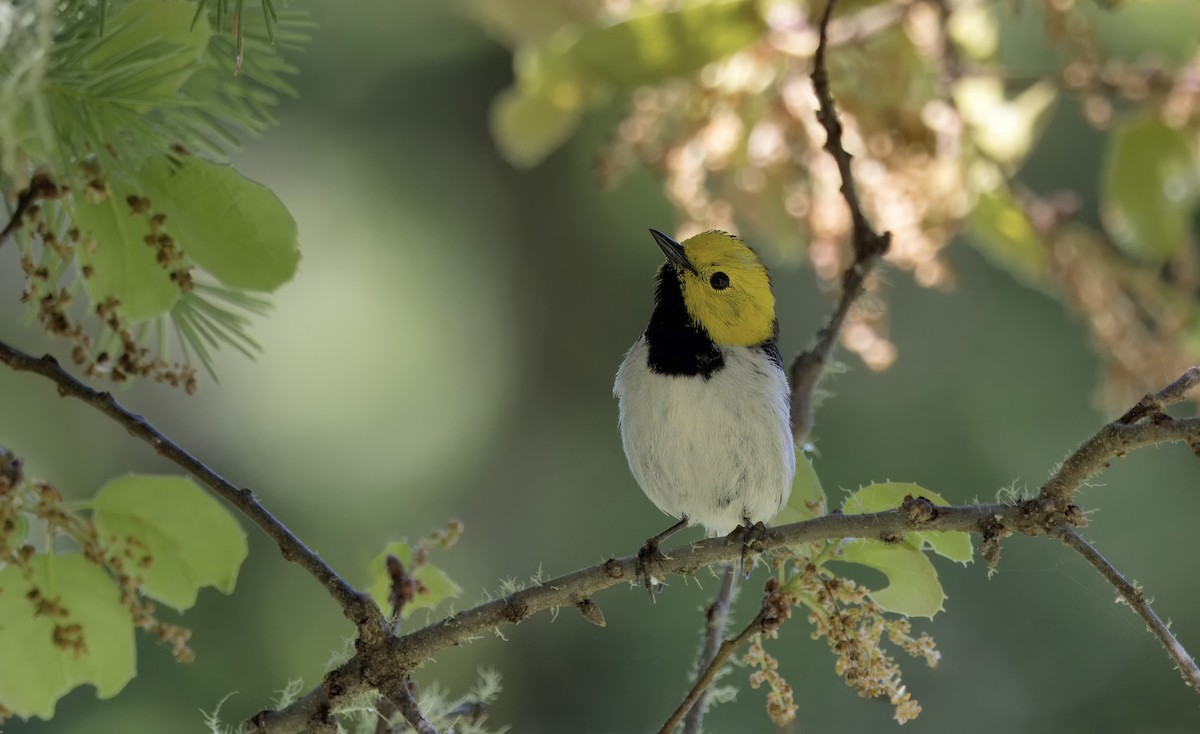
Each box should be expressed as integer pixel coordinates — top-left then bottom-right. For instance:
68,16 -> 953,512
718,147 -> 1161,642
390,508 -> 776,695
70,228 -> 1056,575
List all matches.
139,157 -> 300,290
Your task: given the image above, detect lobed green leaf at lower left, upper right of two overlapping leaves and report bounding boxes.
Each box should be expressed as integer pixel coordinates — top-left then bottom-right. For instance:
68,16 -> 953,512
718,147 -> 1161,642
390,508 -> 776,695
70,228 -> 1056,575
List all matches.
92,474 -> 248,610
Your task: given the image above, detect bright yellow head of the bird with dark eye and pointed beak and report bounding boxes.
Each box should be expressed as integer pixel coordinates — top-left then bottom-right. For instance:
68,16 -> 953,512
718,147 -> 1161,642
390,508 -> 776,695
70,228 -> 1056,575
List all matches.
650,229 -> 775,347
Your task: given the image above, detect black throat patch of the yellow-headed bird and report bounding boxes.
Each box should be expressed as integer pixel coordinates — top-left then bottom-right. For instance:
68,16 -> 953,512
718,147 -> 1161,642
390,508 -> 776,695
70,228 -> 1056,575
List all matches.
646,264 -> 725,380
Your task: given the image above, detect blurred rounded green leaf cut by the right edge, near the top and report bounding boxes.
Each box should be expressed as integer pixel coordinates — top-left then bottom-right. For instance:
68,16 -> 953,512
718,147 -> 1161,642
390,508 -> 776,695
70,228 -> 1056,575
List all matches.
1102,116 -> 1200,263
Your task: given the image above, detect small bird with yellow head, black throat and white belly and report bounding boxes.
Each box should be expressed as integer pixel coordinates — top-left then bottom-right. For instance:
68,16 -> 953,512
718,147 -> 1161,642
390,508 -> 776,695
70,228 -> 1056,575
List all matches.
613,229 -> 796,597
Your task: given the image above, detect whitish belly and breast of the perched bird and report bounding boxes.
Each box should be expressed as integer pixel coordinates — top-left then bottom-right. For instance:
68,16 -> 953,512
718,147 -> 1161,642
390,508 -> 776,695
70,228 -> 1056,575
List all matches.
613,338 -> 796,535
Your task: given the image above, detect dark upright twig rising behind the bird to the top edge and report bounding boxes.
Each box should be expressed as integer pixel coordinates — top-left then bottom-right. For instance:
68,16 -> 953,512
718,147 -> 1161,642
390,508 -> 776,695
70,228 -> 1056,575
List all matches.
790,0 -> 892,445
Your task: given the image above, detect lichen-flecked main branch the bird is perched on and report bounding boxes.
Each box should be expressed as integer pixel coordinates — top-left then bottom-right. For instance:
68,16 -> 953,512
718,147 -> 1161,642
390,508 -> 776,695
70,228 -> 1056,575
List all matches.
250,369 -> 1200,734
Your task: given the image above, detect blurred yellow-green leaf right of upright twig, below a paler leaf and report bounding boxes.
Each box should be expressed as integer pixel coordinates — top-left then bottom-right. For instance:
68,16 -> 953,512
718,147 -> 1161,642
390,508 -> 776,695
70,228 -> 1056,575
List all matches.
967,182 -> 1050,285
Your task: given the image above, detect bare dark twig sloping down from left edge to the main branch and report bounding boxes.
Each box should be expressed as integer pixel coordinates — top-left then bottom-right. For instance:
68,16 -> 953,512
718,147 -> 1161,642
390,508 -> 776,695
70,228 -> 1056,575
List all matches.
0,342 -> 386,639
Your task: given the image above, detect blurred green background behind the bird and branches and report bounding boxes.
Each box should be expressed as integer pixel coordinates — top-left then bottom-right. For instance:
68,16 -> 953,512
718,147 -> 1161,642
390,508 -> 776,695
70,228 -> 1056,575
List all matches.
0,0 -> 1200,734
